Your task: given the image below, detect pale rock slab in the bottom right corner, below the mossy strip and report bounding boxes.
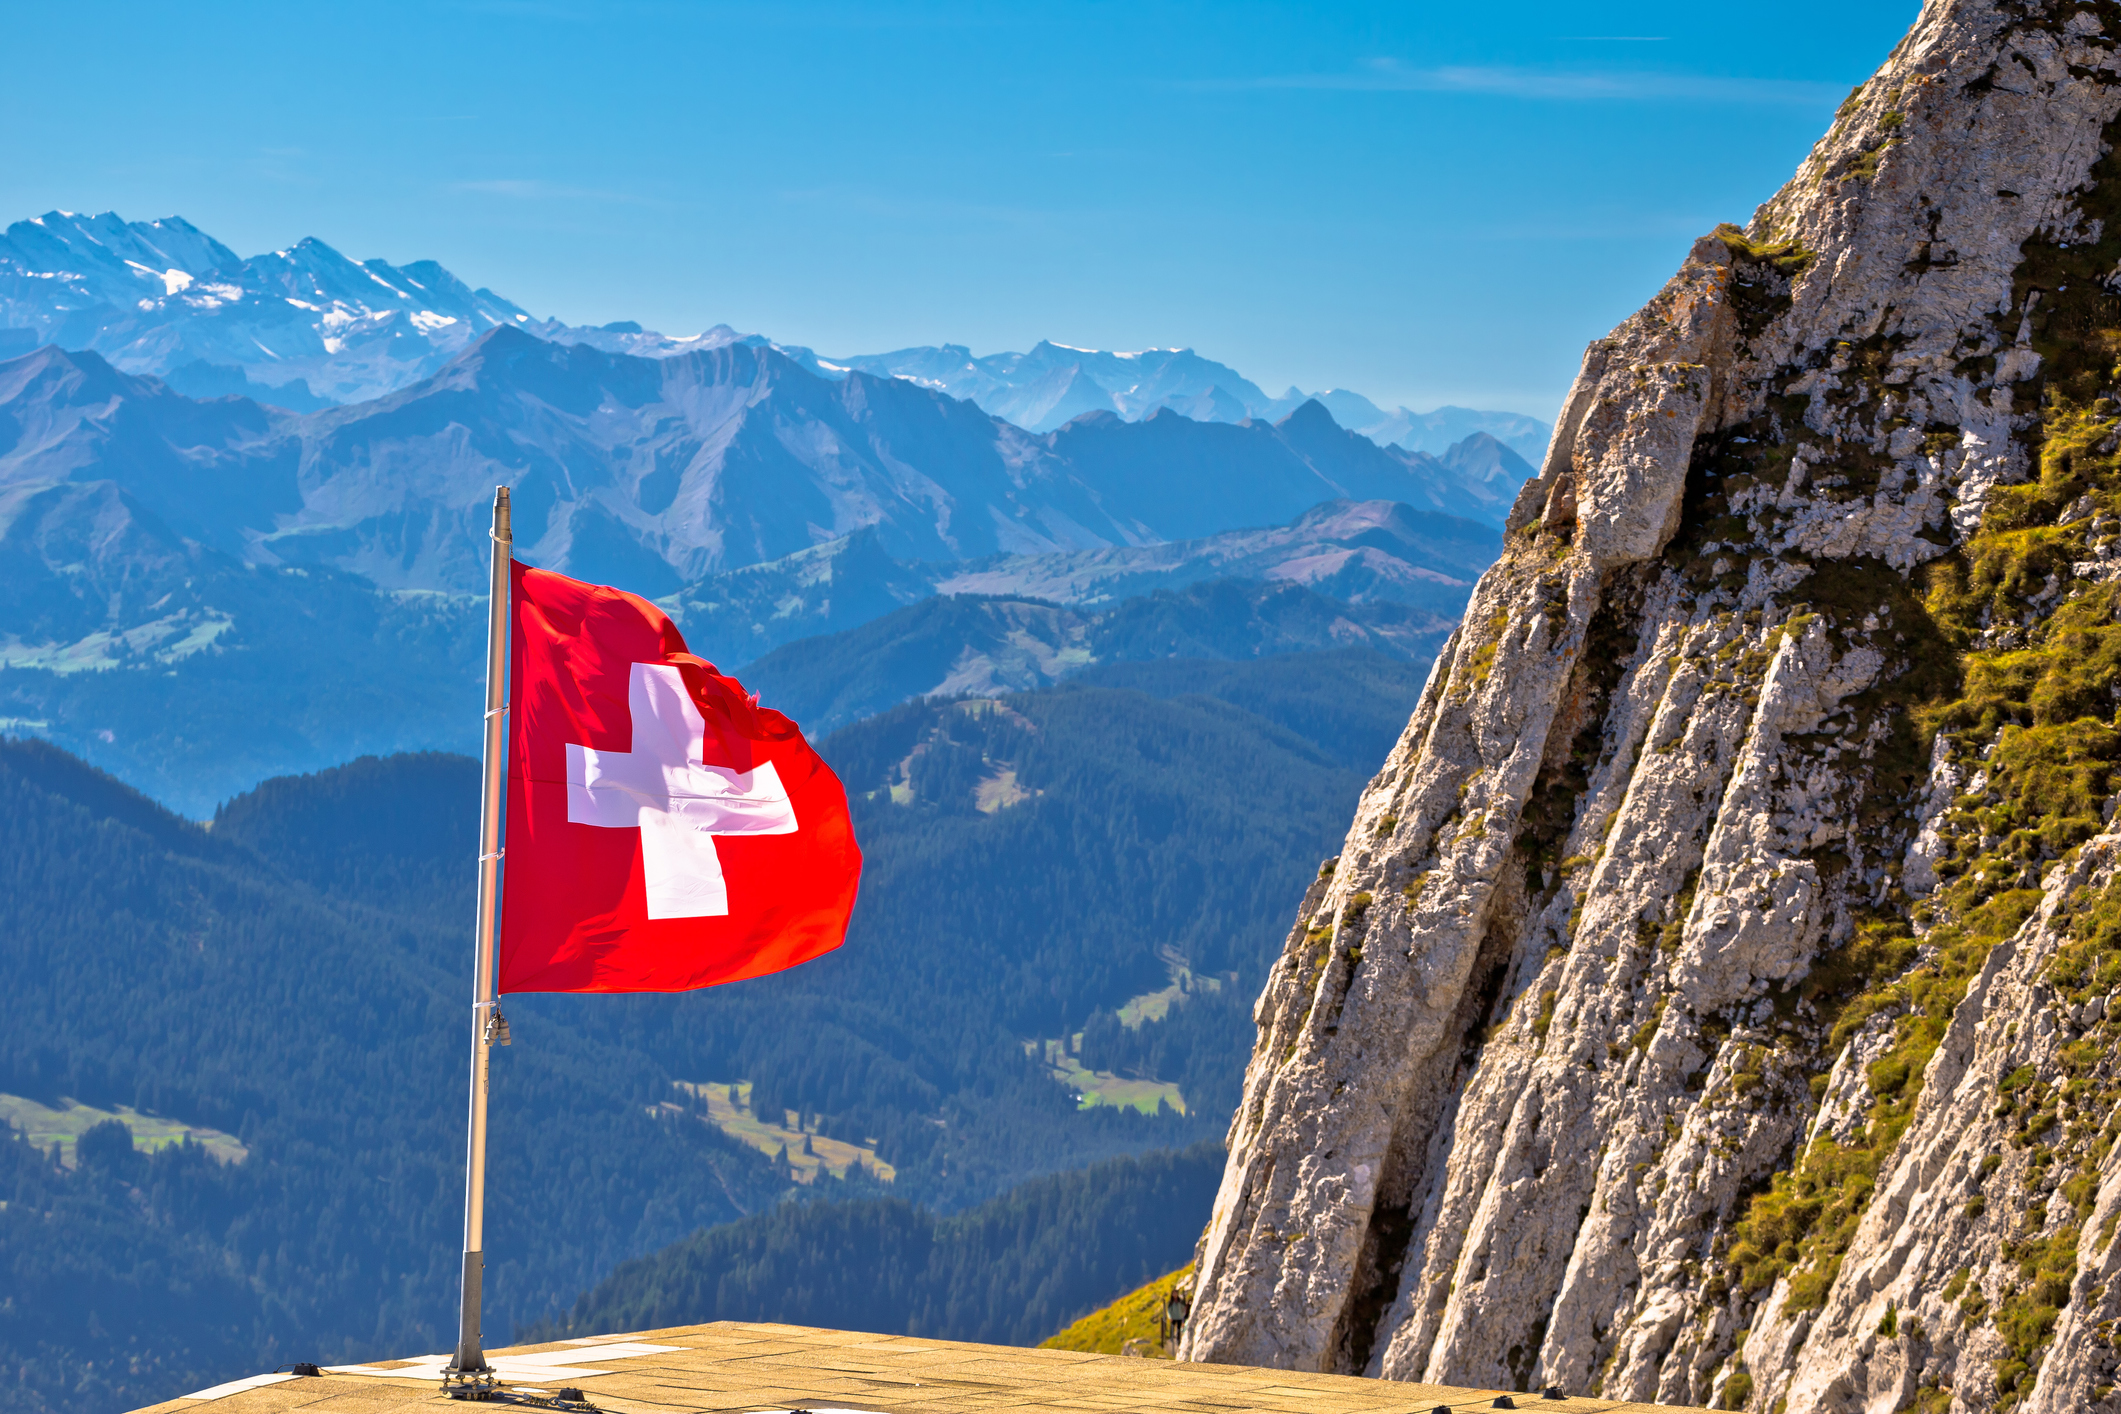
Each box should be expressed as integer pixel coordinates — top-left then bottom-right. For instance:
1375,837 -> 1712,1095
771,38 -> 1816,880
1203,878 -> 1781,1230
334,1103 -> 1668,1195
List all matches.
1746,833 -> 2121,1414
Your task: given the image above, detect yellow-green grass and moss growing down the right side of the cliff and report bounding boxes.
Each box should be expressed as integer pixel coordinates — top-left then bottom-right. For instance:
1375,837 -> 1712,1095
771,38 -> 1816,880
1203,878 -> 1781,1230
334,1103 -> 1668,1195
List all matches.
1726,134 -> 2121,1410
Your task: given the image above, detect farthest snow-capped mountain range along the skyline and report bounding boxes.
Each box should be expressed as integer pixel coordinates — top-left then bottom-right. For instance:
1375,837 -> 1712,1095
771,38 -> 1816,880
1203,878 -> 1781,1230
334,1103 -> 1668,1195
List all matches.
0,212 -> 1550,460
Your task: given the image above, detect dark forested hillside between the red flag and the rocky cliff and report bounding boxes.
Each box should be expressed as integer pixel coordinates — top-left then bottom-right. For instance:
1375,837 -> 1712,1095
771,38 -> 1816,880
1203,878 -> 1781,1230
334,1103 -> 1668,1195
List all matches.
539,651 -> 1421,1210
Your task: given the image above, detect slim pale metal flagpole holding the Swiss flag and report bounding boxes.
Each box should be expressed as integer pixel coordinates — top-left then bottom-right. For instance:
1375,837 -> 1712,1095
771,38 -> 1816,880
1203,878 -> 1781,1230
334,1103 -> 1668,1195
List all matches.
448,485 -> 513,1378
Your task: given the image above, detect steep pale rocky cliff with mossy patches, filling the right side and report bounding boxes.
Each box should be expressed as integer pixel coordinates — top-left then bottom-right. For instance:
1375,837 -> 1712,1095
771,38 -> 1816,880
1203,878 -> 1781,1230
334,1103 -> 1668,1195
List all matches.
1184,0 -> 2121,1414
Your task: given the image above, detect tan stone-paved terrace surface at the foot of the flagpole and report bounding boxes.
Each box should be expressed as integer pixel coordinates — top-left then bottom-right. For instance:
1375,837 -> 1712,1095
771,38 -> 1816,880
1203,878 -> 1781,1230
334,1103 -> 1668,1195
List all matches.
128,1321 -> 1705,1414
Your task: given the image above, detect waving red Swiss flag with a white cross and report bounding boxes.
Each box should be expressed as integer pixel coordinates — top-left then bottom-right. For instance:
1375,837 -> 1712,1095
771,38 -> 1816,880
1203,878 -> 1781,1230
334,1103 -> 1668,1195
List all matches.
501,564 -> 861,992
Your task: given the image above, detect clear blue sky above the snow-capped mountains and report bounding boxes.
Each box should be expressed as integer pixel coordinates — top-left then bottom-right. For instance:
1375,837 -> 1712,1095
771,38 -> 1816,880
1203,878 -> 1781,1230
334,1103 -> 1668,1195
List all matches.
0,0 -> 1917,416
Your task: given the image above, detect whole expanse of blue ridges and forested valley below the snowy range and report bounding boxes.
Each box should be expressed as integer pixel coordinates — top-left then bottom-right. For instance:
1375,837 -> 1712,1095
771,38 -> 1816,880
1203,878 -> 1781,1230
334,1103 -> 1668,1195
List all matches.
0,249 -> 1529,1414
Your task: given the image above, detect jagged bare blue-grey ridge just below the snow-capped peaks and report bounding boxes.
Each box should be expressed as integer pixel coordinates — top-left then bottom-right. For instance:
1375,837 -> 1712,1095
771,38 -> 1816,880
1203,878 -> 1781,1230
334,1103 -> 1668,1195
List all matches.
0,329 -> 1529,594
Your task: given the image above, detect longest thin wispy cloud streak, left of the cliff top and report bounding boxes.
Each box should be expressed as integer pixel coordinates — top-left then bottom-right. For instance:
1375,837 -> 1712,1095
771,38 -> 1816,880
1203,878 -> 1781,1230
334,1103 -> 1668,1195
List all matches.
1188,59 -> 1847,108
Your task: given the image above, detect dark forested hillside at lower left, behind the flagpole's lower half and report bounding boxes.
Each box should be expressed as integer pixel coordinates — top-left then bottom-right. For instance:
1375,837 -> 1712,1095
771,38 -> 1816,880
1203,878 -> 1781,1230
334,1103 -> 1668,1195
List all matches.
0,742 -> 785,1410
